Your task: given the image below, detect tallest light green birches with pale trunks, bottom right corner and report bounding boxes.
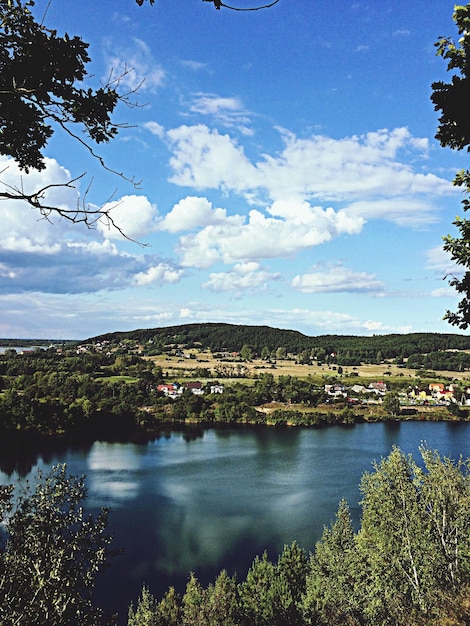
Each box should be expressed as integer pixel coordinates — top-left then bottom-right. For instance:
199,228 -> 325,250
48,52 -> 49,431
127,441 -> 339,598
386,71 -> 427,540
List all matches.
357,448 -> 470,624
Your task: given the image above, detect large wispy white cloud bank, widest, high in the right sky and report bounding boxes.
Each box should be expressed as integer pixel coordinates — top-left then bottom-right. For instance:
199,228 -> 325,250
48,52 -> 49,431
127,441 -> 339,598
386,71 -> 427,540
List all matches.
168,124 -> 453,216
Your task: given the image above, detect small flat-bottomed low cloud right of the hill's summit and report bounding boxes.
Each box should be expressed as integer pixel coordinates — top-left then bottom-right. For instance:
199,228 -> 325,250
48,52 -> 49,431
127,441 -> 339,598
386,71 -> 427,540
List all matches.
292,264 -> 384,293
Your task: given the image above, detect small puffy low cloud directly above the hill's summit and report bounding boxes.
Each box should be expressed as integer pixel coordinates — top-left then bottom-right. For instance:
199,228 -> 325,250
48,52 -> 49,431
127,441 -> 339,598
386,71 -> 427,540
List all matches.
202,261 -> 281,292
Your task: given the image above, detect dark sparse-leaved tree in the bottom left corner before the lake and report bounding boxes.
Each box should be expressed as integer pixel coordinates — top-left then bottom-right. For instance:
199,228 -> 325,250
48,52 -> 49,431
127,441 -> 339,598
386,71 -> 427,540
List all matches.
0,465 -> 112,626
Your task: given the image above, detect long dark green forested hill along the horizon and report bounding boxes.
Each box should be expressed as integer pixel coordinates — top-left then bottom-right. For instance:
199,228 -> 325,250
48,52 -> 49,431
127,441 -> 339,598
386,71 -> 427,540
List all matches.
87,323 -> 470,362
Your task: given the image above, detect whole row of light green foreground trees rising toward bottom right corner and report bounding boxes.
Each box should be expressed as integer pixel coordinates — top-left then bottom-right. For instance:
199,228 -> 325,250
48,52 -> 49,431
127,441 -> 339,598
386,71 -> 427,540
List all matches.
128,448 -> 470,626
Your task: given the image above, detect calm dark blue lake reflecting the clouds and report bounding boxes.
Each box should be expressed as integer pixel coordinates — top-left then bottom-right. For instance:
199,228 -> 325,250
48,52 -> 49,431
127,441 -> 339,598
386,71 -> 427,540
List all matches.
0,422 -> 470,623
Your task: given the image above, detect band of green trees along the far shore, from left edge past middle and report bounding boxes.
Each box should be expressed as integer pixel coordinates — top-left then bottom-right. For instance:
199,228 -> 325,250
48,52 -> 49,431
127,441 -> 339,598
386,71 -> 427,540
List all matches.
0,350 -> 357,439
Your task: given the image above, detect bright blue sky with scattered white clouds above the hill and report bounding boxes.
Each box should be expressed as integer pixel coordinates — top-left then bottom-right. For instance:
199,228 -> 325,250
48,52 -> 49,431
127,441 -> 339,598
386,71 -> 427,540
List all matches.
0,0 -> 469,339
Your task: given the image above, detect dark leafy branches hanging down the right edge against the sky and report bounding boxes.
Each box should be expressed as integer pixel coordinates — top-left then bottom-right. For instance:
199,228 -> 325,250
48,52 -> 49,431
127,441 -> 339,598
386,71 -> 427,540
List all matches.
431,4 -> 470,330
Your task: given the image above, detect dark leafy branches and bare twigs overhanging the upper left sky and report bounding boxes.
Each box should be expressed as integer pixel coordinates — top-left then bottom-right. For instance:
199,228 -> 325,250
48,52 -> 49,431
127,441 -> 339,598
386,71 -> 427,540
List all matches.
0,0 -> 279,236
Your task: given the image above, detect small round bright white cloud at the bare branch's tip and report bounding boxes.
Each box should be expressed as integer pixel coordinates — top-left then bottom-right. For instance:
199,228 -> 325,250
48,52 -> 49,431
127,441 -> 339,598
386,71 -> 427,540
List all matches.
97,195 -> 158,240
